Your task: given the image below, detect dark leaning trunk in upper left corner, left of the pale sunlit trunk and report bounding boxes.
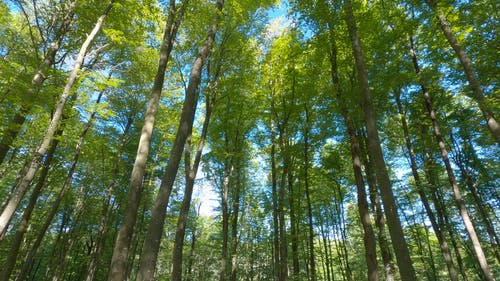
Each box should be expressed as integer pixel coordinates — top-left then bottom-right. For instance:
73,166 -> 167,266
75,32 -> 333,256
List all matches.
0,1 -> 76,164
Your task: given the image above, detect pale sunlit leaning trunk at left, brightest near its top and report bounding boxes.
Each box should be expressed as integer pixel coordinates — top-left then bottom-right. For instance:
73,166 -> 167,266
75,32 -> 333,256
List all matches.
0,1 -> 110,241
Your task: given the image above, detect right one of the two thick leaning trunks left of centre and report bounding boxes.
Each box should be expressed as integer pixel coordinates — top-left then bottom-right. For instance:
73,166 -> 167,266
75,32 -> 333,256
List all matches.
137,0 -> 224,281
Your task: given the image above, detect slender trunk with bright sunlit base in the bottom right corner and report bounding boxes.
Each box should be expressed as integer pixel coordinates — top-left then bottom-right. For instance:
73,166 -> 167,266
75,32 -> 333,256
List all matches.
410,37 -> 494,281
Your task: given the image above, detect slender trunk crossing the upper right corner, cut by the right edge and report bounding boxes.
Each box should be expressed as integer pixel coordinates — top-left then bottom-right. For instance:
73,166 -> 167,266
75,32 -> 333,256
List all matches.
427,0 -> 500,144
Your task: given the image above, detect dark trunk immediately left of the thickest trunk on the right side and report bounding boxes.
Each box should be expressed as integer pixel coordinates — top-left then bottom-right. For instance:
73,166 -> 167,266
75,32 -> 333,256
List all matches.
326,22 -> 378,281
